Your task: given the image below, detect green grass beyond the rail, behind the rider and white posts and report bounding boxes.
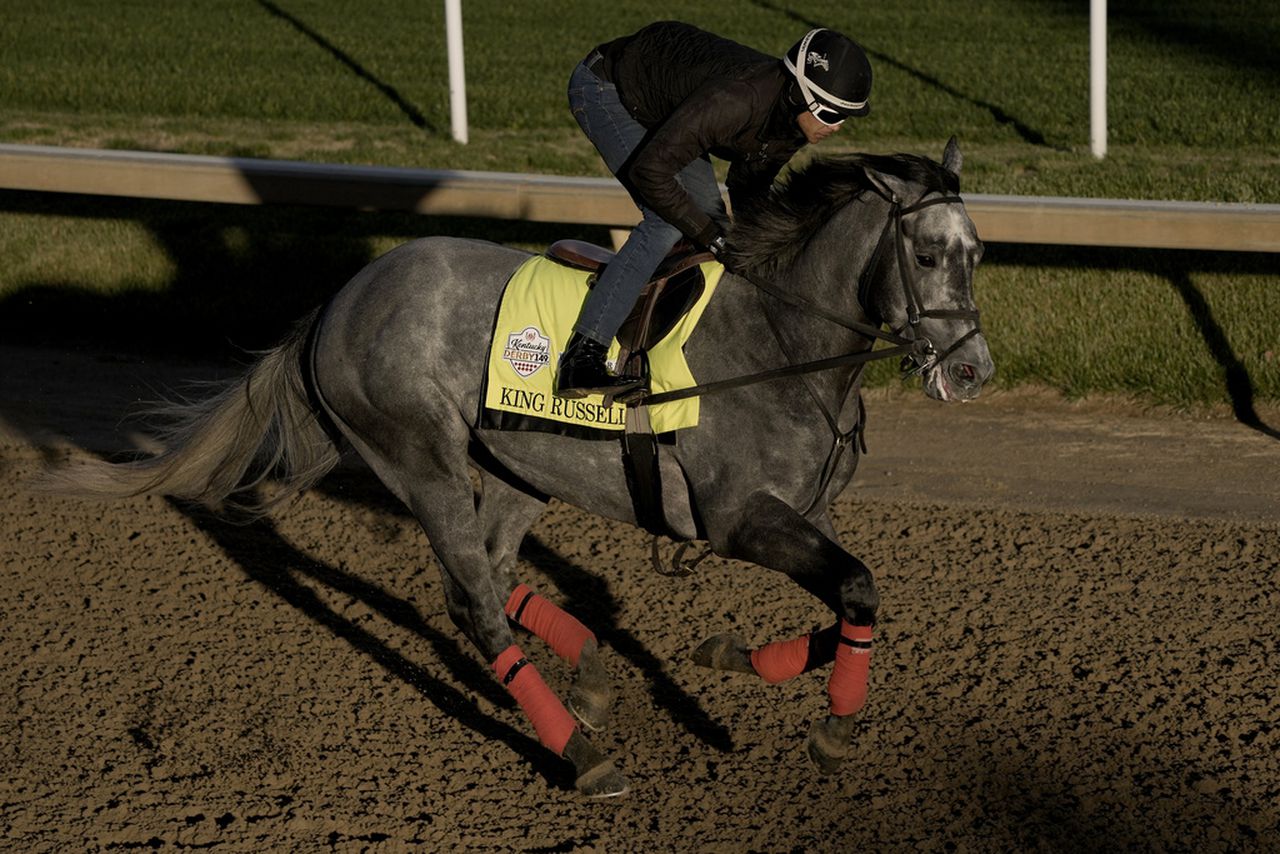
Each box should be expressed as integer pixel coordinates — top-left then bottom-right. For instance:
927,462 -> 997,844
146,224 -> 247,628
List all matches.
0,0 -> 1280,201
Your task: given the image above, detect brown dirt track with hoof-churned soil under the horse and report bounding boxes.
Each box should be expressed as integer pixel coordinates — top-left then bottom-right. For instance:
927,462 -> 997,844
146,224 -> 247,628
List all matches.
0,347 -> 1280,851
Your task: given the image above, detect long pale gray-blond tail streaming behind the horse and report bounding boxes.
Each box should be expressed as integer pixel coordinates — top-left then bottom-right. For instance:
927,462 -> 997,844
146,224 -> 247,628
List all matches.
36,309 -> 340,519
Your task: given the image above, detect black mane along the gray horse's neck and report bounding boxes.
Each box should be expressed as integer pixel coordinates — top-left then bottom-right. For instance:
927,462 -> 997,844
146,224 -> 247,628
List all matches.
728,154 -> 960,275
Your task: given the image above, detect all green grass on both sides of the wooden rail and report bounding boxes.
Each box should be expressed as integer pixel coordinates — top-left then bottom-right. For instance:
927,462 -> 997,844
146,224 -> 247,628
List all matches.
0,0 -> 1280,407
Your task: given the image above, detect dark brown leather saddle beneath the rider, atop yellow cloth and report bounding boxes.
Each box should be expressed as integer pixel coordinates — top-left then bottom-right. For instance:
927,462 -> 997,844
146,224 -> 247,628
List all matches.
547,241 -> 714,362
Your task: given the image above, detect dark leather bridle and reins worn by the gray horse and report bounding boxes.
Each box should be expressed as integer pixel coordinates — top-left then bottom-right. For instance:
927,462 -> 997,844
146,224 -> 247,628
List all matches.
636,184 -> 982,407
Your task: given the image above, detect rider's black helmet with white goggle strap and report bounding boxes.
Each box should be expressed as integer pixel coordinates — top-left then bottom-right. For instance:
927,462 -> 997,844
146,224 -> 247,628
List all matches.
782,28 -> 872,124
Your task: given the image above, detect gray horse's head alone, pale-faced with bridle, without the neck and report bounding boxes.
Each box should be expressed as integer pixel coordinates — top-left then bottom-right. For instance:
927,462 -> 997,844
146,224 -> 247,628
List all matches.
859,137 -> 996,401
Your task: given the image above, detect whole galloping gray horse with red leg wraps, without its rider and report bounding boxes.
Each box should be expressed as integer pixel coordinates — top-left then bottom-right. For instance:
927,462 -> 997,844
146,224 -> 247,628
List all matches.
51,140 -> 993,796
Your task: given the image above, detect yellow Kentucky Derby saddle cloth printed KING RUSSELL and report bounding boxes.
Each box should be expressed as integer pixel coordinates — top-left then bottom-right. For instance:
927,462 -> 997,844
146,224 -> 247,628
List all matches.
481,256 -> 724,439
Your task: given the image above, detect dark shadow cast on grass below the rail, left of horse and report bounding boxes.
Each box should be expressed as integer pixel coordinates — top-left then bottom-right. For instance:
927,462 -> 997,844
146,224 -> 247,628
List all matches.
0,191 -> 588,362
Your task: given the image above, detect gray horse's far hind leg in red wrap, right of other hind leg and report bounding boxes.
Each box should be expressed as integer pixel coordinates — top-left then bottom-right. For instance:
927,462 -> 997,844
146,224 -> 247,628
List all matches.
479,471 -> 613,732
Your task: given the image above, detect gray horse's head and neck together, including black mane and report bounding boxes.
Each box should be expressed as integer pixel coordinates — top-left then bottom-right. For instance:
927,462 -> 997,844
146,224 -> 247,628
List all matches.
730,138 -> 995,401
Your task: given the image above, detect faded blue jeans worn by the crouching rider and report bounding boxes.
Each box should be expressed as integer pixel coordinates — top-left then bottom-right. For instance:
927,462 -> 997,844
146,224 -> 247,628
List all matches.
568,64 -> 727,346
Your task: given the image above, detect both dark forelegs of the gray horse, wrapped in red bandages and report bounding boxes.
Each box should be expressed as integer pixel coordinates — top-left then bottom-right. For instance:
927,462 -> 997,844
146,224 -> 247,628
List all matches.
695,494 -> 879,771
